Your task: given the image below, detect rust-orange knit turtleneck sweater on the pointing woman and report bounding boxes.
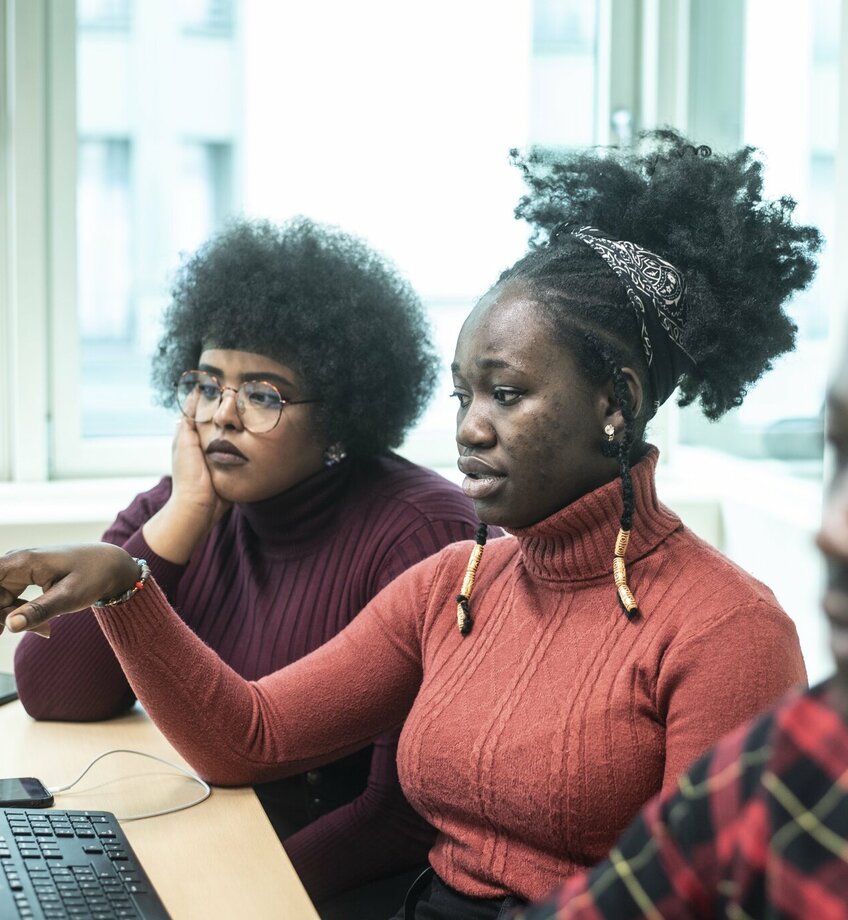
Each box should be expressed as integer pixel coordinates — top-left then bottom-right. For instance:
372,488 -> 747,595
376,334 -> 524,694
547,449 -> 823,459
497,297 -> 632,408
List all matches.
89,451 -> 805,899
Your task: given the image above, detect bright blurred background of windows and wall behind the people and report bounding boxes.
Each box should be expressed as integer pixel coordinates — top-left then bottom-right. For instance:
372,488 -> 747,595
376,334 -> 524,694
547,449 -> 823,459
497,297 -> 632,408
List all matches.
0,0 -> 848,680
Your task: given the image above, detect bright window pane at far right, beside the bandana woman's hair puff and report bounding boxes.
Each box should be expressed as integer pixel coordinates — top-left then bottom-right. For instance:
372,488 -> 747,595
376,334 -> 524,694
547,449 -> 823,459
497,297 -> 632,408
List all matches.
680,0 -> 840,470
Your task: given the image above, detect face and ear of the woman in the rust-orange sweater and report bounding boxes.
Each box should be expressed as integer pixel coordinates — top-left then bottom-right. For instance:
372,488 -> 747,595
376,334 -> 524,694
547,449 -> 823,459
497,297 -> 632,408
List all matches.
451,284 -> 642,529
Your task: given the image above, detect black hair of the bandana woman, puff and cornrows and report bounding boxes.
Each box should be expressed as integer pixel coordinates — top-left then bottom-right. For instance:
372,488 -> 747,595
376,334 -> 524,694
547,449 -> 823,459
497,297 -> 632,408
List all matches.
500,129 -> 822,429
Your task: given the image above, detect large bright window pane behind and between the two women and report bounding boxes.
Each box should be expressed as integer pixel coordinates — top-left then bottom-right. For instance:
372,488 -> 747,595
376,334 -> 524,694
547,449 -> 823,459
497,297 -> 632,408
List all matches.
71,0 -> 599,465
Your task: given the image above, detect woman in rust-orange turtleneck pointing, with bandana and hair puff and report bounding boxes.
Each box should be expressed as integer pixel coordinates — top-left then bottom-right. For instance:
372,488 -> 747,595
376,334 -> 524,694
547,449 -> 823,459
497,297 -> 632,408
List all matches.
0,132 -> 820,918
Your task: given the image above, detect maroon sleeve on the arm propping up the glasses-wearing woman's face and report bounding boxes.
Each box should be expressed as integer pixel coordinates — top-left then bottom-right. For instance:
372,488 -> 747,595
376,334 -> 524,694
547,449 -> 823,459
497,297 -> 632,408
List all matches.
15,478 -> 180,722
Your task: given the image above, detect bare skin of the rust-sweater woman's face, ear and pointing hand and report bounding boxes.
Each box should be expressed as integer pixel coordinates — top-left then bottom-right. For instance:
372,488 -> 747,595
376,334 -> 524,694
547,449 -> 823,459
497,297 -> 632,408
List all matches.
0,284 -> 642,632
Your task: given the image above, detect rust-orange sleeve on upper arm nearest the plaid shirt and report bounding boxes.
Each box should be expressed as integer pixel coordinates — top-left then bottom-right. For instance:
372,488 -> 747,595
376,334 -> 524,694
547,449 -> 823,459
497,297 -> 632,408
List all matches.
657,601 -> 807,791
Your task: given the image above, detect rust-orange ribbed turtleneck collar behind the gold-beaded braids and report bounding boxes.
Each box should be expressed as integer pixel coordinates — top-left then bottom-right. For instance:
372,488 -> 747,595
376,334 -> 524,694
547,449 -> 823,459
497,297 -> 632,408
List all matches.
511,447 -> 680,582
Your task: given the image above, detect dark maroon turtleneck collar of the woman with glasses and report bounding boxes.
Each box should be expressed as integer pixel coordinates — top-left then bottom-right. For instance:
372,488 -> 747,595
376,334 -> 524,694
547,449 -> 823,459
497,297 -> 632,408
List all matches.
236,460 -> 353,546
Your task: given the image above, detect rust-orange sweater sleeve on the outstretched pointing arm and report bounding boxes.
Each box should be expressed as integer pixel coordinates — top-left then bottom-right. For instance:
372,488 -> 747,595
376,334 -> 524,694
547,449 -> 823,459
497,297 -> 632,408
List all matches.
95,557 -> 438,785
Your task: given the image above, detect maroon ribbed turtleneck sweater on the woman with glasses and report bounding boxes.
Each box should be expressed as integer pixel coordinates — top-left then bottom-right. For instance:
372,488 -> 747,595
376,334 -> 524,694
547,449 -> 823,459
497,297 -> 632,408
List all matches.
15,455 -> 486,901
